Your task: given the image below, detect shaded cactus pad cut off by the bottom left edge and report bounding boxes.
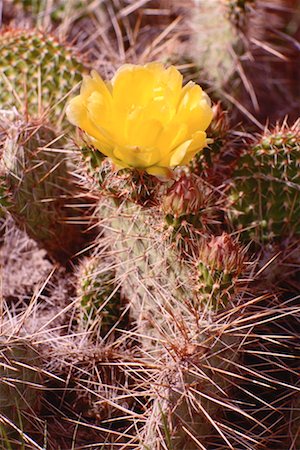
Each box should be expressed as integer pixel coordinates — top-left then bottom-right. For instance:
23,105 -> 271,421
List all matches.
0,336 -> 42,442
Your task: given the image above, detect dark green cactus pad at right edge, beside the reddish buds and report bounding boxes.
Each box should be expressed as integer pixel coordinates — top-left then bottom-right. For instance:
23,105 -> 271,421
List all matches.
230,121 -> 300,243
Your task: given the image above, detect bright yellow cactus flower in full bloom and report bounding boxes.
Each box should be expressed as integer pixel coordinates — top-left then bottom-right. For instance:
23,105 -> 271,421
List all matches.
67,62 -> 213,176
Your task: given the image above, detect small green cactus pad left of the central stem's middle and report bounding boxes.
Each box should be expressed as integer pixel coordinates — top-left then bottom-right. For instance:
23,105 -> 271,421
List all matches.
77,256 -> 122,337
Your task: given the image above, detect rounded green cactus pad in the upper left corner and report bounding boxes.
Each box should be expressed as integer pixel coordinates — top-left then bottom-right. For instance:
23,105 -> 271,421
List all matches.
0,29 -> 84,120
